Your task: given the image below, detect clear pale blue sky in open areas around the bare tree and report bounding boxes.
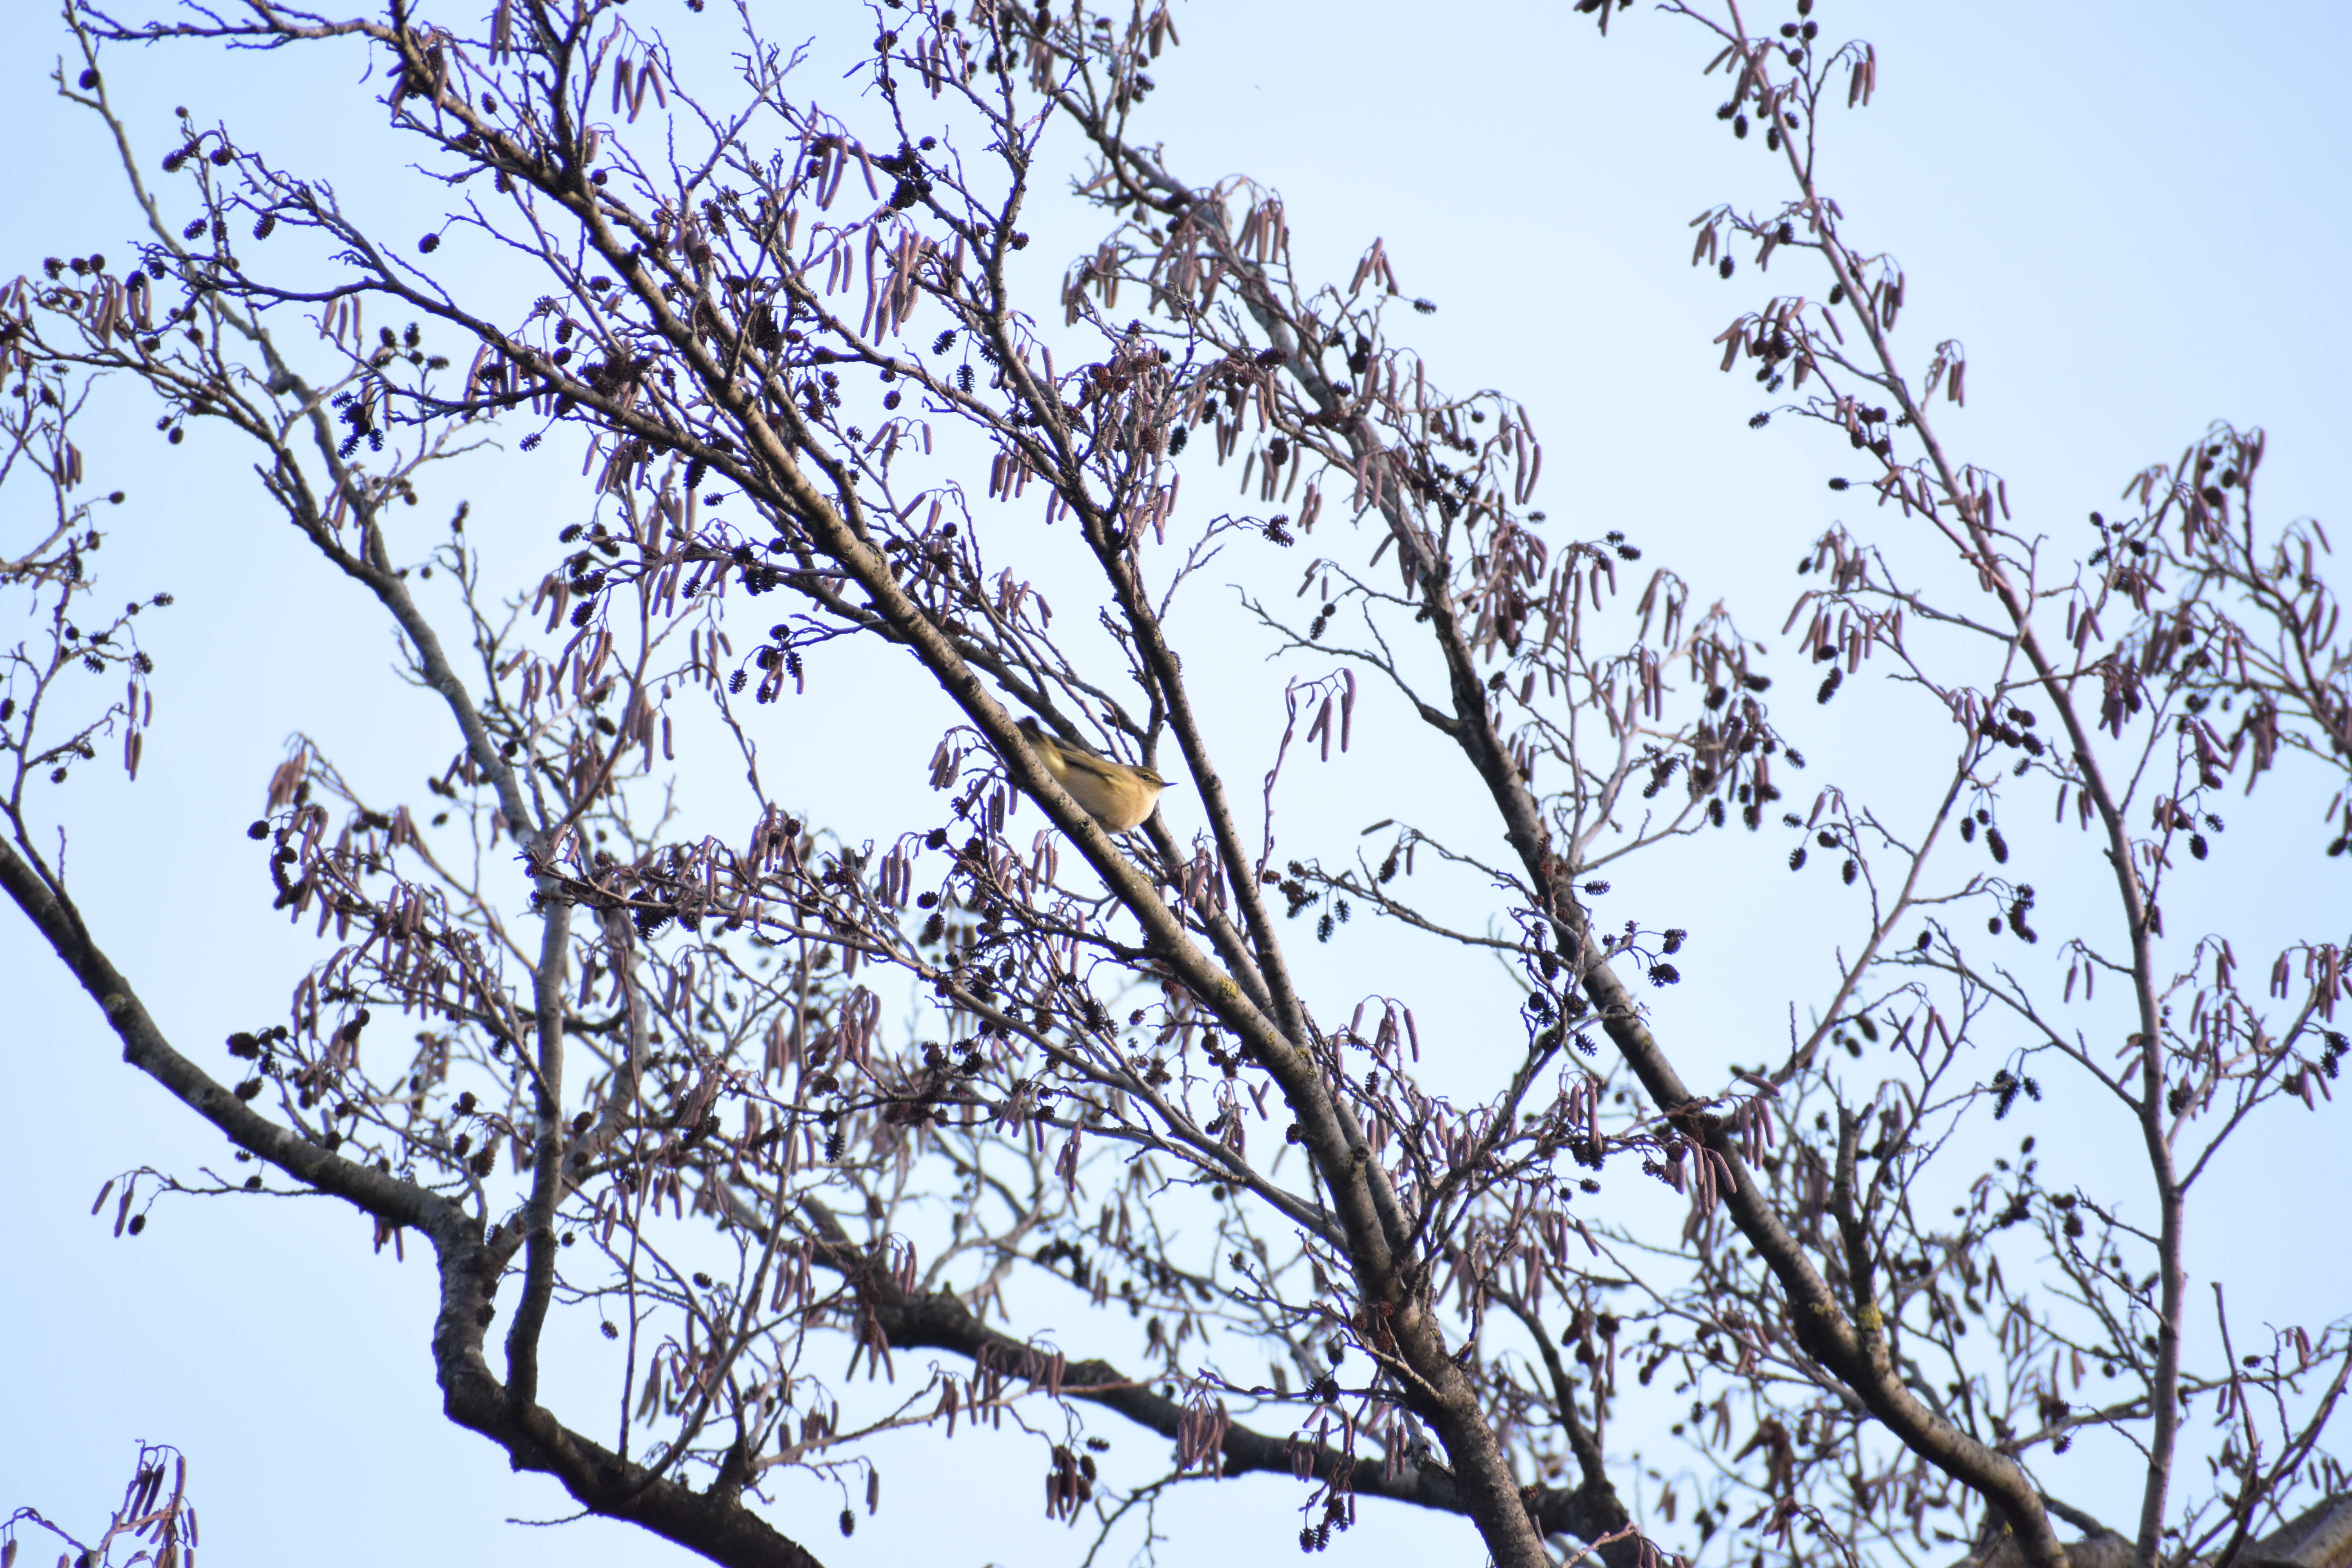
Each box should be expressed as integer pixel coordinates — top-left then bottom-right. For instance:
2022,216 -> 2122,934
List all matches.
0,0 -> 2352,1568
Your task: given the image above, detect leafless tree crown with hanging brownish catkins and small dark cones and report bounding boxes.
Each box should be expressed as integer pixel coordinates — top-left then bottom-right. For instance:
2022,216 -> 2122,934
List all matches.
0,0 -> 2352,1568
